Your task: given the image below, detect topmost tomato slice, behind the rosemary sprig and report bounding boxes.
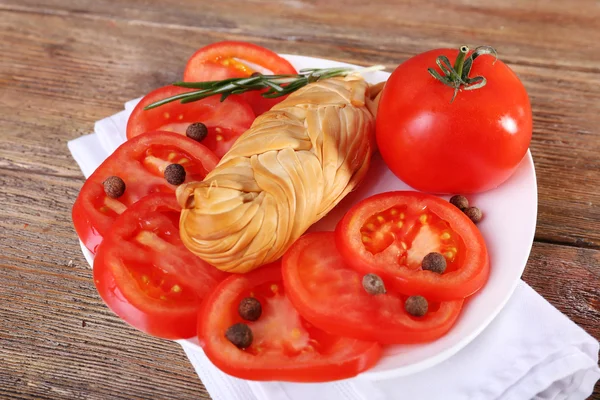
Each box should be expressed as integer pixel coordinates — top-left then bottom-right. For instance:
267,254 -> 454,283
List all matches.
183,41 -> 298,116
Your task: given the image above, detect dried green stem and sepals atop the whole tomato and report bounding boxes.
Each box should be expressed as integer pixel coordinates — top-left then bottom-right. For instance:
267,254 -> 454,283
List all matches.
427,46 -> 498,103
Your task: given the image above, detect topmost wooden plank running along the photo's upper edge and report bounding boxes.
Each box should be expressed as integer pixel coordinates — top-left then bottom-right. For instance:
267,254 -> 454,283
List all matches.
4,0 -> 600,71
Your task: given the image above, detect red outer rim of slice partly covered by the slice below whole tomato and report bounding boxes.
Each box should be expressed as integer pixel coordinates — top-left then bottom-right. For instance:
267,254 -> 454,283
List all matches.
282,232 -> 463,344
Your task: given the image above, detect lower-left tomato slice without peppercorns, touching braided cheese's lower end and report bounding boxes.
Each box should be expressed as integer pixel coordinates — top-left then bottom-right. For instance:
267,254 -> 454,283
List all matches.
94,193 -> 228,339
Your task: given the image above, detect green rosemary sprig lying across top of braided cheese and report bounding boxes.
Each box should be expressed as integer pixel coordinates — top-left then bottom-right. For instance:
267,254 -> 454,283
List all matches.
144,65 -> 385,110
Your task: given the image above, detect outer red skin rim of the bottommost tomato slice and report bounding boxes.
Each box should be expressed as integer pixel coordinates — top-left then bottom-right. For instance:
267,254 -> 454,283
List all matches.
198,262 -> 382,382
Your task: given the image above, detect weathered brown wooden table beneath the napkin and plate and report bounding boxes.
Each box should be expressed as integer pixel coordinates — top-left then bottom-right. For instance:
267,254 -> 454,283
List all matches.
0,0 -> 600,399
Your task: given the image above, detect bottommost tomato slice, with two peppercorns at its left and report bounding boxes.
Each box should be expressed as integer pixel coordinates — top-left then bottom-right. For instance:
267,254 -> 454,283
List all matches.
198,264 -> 381,382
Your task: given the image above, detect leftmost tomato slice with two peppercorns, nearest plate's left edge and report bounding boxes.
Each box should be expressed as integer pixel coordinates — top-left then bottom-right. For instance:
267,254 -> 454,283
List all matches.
73,132 -> 219,253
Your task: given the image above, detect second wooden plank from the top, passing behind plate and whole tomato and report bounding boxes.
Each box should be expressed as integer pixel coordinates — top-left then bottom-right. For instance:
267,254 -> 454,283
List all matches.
0,12 -> 600,248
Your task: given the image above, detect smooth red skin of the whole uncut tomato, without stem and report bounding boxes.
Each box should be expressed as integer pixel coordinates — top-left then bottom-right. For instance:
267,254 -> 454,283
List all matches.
376,49 -> 532,194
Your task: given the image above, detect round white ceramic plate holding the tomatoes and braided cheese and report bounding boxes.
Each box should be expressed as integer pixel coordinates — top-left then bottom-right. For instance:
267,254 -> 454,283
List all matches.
77,55 -> 537,380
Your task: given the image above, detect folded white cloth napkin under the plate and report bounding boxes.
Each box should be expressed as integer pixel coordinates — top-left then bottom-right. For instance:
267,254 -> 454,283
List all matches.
68,99 -> 600,400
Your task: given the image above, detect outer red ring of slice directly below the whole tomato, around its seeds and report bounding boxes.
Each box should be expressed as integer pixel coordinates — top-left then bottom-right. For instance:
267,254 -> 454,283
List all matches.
335,192 -> 490,301
